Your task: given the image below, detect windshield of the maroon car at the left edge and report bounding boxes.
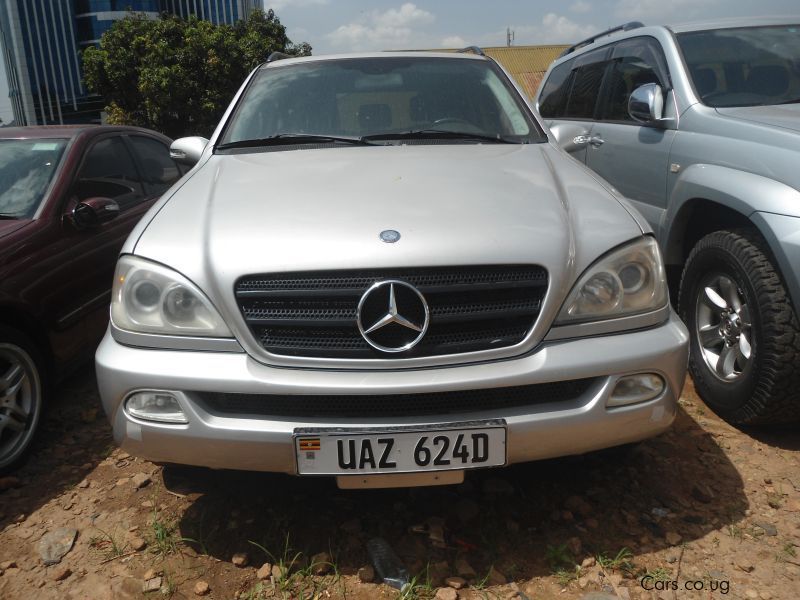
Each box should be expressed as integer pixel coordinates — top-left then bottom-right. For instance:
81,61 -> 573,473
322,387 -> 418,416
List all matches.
0,139 -> 68,218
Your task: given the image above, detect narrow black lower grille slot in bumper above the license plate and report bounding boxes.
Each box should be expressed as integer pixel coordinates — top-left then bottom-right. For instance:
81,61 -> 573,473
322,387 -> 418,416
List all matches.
198,379 -> 596,418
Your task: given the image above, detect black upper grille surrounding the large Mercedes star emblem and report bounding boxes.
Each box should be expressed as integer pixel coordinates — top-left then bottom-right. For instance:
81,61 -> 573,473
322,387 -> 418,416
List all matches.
235,265 -> 547,358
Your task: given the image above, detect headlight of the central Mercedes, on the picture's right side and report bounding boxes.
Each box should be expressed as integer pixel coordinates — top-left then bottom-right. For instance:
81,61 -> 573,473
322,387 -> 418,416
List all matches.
558,237 -> 667,324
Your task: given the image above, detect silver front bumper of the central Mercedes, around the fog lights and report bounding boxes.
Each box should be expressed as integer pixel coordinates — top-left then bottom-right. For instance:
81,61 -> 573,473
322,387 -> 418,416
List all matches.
96,312 -> 688,474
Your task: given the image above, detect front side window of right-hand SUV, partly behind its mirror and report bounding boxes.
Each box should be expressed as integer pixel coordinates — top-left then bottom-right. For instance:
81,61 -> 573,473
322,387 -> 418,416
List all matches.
601,38 -> 664,125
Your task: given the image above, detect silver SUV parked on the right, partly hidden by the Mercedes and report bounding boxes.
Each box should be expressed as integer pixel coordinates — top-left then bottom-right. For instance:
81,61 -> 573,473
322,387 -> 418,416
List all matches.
538,18 -> 800,424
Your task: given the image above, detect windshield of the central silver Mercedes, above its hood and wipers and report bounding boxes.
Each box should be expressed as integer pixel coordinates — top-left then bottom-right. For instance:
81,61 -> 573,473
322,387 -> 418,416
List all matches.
220,57 -> 544,144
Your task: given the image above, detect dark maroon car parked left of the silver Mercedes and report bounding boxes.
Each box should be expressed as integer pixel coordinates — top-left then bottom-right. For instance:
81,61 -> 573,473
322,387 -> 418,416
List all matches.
0,125 -> 182,472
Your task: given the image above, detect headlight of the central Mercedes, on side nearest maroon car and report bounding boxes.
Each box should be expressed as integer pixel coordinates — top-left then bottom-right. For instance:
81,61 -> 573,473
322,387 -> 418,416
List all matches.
111,256 -> 232,337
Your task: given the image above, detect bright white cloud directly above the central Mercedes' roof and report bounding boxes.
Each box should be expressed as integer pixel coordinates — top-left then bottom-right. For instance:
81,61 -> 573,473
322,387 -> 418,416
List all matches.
325,2 -> 436,50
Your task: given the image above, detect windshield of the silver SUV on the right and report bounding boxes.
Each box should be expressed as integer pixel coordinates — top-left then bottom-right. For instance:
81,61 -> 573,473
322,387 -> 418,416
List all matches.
677,25 -> 800,107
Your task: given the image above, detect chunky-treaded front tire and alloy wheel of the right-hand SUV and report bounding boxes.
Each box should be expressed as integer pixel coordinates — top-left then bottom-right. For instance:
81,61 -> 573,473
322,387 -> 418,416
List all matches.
679,230 -> 800,425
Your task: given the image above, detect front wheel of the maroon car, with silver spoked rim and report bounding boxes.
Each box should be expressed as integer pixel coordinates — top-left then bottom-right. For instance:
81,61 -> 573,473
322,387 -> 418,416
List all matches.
0,326 -> 44,474
